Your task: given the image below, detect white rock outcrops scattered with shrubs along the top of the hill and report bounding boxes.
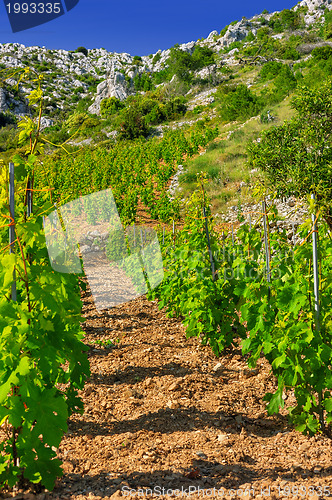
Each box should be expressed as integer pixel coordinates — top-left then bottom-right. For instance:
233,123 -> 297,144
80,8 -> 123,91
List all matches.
0,0 -> 332,114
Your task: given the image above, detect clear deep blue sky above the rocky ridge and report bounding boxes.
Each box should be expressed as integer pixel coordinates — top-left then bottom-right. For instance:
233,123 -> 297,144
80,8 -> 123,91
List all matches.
0,0 -> 297,55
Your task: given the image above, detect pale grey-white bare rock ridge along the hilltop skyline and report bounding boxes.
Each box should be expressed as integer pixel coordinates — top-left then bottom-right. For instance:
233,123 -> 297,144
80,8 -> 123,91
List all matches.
0,0 -> 332,119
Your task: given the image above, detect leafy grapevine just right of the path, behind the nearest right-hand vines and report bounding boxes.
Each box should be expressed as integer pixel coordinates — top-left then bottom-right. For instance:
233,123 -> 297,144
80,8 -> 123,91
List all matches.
148,174 -> 245,355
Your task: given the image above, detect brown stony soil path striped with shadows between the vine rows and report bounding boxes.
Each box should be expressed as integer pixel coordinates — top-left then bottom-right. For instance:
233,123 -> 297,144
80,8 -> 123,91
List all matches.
2,276 -> 332,500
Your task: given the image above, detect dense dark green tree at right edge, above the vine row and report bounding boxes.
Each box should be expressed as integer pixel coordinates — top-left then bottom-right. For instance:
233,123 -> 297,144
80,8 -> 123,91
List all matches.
248,79 -> 332,228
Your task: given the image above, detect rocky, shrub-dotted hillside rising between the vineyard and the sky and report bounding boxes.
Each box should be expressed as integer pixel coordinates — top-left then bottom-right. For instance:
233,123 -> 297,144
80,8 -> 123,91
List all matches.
0,3 -> 332,223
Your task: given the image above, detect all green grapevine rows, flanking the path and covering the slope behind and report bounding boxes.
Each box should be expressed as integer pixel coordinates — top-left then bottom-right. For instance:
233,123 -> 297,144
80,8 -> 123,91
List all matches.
0,64 -> 332,498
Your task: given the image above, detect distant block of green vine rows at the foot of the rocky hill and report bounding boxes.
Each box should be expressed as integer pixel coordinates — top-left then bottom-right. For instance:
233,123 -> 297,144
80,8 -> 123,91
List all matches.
35,122 -> 218,225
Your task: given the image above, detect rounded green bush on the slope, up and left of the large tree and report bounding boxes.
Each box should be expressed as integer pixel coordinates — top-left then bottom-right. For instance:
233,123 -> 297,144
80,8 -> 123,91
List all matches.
216,84 -> 262,122
